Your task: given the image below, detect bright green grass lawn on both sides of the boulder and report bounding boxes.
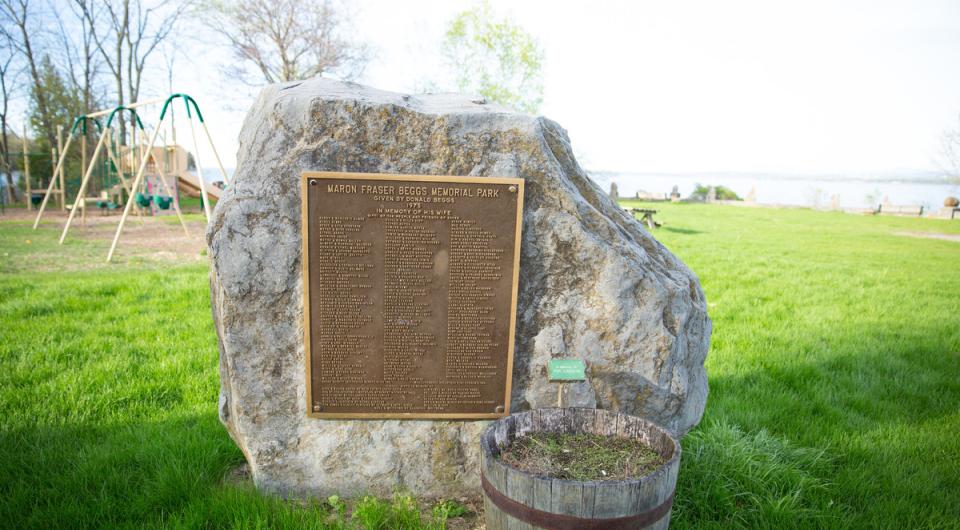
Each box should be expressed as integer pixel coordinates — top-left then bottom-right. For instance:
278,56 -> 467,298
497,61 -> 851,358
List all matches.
0,202 -> 960,528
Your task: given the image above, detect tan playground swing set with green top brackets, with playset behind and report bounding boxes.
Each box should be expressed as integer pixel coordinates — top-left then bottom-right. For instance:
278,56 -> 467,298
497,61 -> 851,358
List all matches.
27,93 -> 229,262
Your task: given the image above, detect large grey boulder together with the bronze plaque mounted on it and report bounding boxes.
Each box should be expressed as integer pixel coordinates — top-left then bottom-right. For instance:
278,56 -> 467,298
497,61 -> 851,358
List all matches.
207,79 -> 711,497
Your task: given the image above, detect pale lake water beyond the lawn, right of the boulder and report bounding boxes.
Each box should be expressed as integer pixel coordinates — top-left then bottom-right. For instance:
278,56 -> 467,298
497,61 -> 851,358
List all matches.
590,172 -> 960,209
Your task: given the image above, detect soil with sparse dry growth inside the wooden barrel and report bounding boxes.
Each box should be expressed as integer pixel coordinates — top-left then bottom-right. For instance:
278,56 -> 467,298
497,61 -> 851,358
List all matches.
500,432 -> 666,481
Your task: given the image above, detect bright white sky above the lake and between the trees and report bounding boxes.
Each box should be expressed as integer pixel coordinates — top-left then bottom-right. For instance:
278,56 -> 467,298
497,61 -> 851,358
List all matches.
82,0 -> 960,175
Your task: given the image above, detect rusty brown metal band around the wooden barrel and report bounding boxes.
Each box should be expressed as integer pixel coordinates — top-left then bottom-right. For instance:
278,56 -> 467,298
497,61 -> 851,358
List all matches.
480,473 -> 674,530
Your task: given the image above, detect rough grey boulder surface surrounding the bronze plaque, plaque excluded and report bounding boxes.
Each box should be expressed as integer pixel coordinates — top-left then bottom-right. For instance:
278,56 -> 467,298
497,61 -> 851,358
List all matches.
207,79 -> 711,496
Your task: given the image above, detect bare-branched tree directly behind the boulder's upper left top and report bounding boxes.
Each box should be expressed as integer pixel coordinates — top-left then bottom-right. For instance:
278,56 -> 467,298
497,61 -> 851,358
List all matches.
202,0 -> 370,83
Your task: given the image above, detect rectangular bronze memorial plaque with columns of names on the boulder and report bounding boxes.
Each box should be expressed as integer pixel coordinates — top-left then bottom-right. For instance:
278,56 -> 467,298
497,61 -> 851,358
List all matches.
302,172 -> 523,419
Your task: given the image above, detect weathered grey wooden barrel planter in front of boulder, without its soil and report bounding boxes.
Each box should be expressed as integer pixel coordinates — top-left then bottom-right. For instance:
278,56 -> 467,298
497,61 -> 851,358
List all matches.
480,408 -> 680,530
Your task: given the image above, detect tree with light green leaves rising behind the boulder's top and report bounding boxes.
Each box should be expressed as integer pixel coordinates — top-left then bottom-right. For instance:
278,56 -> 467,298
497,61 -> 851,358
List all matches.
442,0 -> 543,113
